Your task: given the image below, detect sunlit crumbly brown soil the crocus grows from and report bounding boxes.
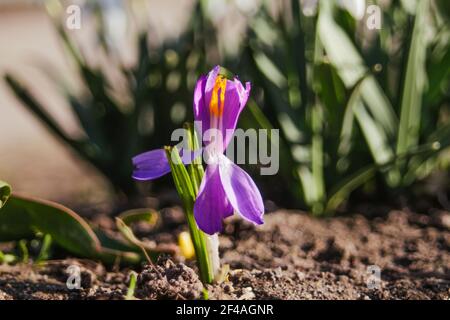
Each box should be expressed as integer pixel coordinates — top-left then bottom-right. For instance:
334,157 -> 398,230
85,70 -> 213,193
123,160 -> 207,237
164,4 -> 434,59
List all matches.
0,211 -> 450,300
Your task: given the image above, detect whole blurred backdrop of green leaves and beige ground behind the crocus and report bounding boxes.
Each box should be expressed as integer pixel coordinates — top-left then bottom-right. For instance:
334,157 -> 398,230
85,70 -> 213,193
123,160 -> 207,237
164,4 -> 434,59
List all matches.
0,0 -> 450,215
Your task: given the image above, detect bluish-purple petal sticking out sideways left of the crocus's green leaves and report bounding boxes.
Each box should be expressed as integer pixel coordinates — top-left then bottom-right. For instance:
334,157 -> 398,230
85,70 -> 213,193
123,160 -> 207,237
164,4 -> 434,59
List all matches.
132,149 -> 170,180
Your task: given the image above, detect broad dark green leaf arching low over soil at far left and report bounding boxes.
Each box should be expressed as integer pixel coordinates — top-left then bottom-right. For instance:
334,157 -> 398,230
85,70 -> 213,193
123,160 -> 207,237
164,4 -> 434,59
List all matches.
0,194 -> 141,264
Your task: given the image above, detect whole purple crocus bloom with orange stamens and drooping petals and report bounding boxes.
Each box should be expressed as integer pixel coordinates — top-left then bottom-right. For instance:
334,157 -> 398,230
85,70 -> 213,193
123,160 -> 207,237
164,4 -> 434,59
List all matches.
133,66 -> 264,235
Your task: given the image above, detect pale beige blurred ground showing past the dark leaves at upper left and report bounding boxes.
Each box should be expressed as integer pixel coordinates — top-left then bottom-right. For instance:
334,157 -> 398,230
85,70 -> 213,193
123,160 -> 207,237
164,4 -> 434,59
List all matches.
0,0 -> 194,203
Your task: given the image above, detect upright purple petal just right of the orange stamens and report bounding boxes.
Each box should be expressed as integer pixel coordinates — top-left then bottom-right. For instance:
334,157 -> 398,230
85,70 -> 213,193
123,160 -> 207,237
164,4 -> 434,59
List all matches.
220,78 -> 250,151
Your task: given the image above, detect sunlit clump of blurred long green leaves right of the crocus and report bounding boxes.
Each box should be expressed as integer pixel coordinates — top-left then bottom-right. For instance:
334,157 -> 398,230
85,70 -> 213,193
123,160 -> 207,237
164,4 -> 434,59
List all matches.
239,1 -> 450,214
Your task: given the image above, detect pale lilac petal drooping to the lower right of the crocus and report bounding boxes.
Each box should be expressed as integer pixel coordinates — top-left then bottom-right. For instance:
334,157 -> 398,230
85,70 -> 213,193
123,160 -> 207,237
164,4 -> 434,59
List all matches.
219,155 -> 264,224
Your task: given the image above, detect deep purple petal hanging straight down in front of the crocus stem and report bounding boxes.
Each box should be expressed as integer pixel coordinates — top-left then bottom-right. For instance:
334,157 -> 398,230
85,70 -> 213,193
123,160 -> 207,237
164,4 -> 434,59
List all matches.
194,164 -> 233,235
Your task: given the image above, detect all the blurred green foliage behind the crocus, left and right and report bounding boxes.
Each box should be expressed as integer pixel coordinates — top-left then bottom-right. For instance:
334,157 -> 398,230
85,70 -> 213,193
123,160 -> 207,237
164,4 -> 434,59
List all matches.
6,0 -> 450,214
